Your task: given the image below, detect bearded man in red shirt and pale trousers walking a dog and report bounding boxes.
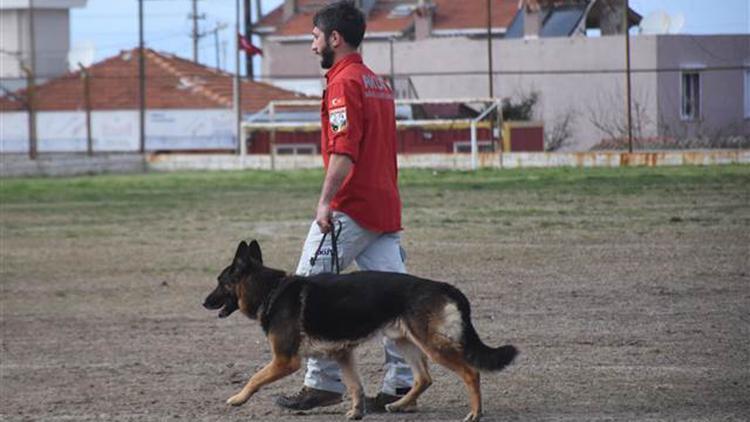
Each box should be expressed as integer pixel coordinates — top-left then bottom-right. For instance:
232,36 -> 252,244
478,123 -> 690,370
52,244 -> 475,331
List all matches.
276,1 -> 413,411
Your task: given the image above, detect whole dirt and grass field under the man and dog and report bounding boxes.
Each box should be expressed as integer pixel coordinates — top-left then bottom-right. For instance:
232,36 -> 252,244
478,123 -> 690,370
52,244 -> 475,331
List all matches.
0,166 -> 750,422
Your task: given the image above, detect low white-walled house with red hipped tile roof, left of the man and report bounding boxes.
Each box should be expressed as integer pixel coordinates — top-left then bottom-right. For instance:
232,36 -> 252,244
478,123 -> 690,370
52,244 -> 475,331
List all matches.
0,49 -> 310,152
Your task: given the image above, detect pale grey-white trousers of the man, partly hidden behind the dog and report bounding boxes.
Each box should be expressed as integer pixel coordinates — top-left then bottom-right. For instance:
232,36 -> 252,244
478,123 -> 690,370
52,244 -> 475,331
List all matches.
297,212 -> 414,394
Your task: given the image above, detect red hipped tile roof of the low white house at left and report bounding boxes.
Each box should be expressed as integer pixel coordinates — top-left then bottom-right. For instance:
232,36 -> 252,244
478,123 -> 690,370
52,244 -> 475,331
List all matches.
0,49 -> 312,112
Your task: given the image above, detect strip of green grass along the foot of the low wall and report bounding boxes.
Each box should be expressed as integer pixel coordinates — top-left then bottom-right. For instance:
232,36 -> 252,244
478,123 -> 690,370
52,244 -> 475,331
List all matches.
0,165 -> 750,205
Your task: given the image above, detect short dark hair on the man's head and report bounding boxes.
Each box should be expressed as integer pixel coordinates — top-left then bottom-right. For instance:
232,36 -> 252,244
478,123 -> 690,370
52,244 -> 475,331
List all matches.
313,0 -> 367,48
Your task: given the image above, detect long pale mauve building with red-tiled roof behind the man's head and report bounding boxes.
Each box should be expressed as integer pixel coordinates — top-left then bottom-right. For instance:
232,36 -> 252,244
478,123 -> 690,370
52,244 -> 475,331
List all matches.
254,0 -> 750,151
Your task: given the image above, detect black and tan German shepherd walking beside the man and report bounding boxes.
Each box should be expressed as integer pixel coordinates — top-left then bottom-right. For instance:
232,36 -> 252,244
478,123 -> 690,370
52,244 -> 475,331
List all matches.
203,240 -> 518,421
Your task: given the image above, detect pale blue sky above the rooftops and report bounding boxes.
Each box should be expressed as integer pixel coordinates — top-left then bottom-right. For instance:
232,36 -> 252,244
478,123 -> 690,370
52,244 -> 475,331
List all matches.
71,0 -> 750,72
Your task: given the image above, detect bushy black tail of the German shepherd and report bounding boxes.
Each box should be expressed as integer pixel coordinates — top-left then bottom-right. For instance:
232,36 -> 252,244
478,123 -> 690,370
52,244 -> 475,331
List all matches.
449,285 -> 518,371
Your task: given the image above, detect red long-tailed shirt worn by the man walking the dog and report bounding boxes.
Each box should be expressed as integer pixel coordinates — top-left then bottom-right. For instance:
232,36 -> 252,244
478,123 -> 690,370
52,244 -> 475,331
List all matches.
321,53 -> 401,232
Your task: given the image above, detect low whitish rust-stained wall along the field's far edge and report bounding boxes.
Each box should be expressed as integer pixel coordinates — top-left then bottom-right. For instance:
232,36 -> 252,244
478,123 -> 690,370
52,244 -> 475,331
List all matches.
0,150 -> 750,177
